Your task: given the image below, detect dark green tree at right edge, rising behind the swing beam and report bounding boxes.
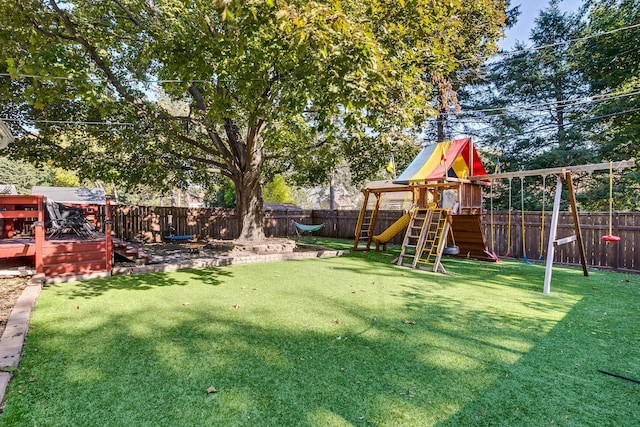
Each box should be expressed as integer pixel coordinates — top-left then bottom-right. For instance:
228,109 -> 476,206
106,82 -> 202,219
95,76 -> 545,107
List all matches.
578,0 -> 640,210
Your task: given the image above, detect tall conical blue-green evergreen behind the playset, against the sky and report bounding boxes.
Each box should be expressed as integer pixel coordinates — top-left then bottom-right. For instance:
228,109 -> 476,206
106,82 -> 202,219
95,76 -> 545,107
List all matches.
463,0 -> 594,170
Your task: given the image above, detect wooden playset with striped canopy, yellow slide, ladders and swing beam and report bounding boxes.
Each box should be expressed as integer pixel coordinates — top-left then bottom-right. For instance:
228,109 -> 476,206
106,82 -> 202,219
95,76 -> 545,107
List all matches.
353,138 -> 635,294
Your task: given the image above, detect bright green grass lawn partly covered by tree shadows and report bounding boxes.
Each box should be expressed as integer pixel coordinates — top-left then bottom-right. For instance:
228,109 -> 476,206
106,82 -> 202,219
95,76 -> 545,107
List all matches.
0,241 -> 640,426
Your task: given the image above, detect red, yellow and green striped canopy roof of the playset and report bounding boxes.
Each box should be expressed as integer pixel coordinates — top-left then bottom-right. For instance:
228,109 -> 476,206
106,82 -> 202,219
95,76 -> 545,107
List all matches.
394,138 -> 487,184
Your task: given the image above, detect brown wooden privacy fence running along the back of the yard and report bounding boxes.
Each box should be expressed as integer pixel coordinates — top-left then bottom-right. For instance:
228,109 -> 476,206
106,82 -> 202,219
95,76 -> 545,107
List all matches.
101,206 -> 640,273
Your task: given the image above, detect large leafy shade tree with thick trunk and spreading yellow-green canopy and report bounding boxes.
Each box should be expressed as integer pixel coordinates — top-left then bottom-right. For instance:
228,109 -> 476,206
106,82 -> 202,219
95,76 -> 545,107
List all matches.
0,0 -> 506,240
